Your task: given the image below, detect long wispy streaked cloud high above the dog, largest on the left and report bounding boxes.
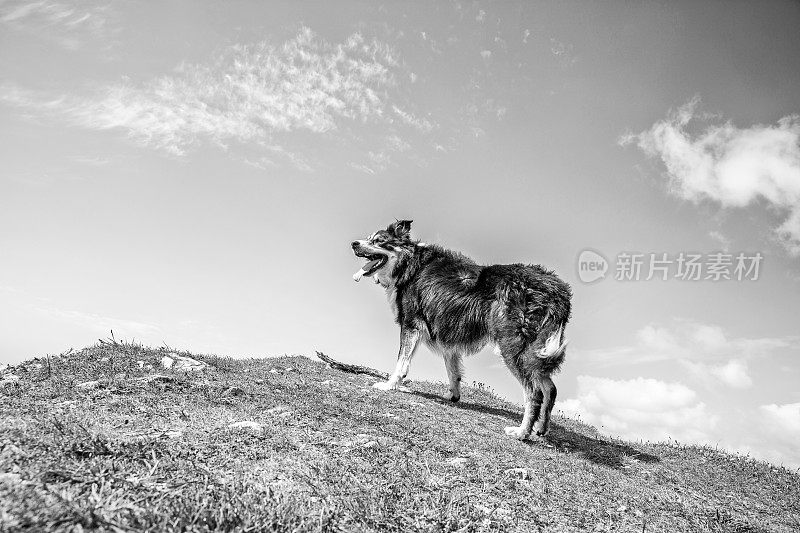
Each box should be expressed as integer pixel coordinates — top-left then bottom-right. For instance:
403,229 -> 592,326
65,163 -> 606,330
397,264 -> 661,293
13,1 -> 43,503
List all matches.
0,28 -> 435,166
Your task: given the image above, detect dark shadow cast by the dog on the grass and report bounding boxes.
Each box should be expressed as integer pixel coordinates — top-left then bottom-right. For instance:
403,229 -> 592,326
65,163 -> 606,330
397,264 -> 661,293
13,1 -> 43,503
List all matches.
413,391 -> 661,468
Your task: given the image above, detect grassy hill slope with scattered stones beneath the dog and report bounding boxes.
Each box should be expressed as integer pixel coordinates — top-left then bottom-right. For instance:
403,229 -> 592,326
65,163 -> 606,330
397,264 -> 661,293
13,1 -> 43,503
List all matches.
0,342 -> 800,532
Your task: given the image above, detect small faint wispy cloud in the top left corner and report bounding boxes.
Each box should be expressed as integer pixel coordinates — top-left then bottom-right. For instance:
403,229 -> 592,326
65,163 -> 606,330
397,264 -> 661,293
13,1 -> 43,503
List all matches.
0,0 -> 112,49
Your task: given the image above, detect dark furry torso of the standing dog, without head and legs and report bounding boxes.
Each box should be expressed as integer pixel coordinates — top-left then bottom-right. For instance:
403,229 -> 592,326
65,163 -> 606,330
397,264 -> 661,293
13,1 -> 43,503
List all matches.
396,246 -> 571,371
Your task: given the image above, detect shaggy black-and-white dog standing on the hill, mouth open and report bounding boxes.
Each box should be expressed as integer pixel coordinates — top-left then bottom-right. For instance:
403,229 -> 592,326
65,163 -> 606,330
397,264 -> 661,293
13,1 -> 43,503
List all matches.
351,220 -> 572,440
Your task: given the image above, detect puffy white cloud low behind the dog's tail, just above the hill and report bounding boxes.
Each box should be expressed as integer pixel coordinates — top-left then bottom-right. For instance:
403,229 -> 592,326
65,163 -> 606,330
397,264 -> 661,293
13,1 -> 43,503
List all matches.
558,376 -> 717,443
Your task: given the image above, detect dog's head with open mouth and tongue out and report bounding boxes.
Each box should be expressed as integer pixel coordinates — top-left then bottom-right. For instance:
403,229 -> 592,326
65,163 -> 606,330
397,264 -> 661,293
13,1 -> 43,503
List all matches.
352,220 -> 417,286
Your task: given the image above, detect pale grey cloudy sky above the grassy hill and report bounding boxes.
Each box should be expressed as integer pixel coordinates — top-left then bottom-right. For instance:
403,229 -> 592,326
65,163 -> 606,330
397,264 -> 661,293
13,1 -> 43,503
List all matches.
0,0 -> 800,468
